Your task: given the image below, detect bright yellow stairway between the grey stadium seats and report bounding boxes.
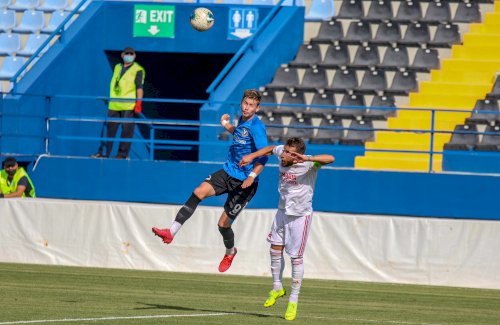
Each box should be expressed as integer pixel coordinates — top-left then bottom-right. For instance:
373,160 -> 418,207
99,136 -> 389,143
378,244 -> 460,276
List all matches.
355,1 -> 500,171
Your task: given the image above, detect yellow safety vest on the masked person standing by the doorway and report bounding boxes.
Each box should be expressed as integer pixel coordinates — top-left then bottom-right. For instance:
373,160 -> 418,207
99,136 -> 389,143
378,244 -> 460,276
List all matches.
108,62 -> 146,111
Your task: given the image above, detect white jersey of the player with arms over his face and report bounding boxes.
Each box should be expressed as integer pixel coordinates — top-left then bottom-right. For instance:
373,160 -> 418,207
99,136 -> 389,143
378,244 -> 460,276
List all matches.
273,145 -> 321,216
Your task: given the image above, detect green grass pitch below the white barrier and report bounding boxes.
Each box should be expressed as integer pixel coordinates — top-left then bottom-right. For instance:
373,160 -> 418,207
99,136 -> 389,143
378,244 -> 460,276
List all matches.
0,263 -> 500,325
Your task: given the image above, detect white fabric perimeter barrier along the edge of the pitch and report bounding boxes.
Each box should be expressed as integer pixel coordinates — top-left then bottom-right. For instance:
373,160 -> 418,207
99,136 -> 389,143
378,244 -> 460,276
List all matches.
0,199 -> 500,289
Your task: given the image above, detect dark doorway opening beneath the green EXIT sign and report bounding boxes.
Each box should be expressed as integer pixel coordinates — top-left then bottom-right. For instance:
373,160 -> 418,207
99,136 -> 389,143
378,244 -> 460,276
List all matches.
106,51 -> 232,161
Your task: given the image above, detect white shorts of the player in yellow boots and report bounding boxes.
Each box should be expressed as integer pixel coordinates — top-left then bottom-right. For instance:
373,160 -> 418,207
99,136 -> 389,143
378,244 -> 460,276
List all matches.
267,210 -> 312,258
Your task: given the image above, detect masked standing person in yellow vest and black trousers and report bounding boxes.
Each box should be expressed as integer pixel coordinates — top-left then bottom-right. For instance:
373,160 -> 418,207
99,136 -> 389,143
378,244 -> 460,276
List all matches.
92,47 -> 146,159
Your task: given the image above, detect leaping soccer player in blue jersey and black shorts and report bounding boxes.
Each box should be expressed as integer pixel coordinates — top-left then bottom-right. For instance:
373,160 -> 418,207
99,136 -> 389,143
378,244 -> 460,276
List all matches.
153,89 -> 268,272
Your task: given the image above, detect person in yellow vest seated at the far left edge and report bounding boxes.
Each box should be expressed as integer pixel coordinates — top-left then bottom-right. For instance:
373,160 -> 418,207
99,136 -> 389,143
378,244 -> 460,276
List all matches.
0,157 -> 35,198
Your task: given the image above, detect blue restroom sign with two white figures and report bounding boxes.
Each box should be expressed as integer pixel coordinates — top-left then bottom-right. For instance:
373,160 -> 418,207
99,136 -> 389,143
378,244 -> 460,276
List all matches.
227,7 -> 259,40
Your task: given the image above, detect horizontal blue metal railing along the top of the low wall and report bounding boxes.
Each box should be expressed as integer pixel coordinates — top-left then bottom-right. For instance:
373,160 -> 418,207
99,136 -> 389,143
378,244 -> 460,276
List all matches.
0,93 -> 500,172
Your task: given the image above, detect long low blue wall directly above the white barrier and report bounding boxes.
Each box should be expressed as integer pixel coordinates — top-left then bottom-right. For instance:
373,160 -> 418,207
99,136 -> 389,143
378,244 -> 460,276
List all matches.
29,158 -> 500,220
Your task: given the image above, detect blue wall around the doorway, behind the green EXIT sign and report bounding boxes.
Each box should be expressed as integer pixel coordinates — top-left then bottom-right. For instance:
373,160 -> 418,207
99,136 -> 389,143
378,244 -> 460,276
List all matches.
1,1 -> 286,155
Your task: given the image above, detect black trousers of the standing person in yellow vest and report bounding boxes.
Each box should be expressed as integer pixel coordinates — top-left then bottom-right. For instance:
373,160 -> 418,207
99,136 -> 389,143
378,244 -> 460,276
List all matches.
99,109 -> 135,157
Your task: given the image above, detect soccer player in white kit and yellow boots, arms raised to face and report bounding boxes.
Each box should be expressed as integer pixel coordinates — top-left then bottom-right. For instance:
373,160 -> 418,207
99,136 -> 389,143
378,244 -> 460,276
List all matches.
240,138 -> 335,320
